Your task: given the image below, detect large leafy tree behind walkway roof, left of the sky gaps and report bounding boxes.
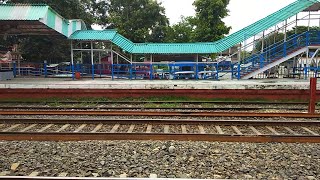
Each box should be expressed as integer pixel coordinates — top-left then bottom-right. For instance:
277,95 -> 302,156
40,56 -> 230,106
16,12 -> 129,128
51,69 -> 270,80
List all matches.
95,0 -> 169,42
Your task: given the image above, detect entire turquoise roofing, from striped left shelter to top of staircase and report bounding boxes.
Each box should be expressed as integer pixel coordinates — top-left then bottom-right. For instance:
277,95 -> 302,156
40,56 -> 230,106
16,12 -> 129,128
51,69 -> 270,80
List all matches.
0,0 -> 320,54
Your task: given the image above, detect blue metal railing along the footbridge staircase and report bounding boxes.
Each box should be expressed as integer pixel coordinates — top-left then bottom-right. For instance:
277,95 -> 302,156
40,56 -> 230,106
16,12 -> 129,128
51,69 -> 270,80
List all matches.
233,31 -> 320,79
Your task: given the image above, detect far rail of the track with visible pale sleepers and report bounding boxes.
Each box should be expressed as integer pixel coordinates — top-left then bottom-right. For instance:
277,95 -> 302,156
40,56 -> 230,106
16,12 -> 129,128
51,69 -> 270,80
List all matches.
0,118 -> 320,126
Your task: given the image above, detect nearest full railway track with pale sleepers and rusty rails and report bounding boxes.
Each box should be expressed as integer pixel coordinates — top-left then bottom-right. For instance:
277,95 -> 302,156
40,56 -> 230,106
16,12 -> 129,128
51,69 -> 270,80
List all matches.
0,119 -> 320,143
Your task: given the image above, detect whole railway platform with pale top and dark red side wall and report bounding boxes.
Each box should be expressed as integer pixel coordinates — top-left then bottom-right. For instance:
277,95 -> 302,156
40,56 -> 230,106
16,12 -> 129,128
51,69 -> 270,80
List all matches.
0,78 -> 320,101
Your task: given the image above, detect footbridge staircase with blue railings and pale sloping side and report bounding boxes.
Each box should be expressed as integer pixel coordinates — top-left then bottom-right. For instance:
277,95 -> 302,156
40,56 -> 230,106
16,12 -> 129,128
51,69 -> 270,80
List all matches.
234,31 -> 320,79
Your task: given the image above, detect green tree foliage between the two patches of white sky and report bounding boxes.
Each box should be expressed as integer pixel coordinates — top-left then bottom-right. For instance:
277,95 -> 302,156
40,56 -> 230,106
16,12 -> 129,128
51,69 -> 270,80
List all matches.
166,0 -> 231,42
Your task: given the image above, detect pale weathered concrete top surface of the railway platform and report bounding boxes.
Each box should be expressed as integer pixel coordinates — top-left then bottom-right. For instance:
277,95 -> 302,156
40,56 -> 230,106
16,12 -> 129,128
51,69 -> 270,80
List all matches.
0,78 -> 320,90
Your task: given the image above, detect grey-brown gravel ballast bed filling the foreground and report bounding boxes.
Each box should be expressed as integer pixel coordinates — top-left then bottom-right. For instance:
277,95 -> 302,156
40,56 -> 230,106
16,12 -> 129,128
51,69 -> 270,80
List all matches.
0,141 -> 320,179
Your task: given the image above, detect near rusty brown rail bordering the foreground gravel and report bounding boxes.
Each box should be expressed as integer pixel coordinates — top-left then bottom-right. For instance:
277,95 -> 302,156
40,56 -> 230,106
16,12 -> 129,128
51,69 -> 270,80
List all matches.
0,132 -> 320,143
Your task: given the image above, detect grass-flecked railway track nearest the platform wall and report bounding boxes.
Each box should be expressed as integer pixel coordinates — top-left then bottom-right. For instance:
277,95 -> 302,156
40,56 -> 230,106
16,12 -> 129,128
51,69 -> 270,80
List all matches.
0,101 -> 319,112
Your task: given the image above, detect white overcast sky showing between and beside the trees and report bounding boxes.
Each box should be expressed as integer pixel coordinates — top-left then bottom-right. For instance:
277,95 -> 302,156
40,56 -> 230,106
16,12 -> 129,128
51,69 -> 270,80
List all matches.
158,0 -> 295,33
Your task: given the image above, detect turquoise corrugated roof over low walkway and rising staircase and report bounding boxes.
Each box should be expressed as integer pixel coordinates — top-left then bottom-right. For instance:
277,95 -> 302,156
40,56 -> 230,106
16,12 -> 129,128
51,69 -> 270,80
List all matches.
71,0 -> 320,54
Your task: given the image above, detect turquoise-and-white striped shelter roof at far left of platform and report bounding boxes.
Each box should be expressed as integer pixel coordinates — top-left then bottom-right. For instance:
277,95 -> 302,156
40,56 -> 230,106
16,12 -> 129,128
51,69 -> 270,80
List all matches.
0,4 -> 86,37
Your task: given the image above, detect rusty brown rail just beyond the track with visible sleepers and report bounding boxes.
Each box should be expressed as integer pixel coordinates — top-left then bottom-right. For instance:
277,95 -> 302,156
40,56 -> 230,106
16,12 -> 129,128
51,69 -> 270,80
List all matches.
0,111 -> 320,118
